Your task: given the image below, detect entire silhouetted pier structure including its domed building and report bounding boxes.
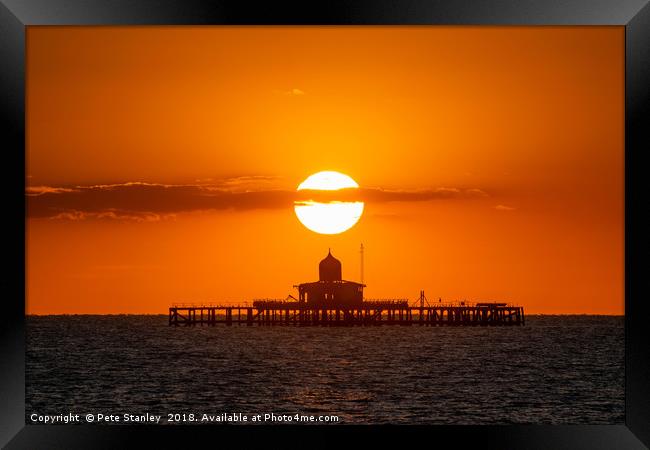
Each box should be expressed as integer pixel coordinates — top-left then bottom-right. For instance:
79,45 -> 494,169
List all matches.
169,246 -> 525,326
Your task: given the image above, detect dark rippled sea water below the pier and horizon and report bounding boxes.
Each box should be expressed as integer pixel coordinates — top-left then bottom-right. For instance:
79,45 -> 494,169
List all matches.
26,316 -> 624,424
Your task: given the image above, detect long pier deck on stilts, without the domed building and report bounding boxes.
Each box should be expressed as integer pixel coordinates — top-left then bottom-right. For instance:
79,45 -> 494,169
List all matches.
169,300 -> 525,327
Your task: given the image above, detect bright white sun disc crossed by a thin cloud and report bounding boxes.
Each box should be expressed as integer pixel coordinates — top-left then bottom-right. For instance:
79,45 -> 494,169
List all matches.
294,170 -> 364,234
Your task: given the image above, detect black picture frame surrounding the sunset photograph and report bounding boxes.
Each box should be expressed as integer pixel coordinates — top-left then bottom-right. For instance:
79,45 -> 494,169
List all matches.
0,0 -> 650,449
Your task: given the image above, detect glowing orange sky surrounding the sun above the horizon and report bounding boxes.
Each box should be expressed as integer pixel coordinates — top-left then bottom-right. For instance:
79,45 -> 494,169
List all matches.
26,27 -> 624,314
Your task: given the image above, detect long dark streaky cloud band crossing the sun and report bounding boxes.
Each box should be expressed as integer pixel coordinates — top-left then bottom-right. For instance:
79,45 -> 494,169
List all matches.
25,180 -> 487,222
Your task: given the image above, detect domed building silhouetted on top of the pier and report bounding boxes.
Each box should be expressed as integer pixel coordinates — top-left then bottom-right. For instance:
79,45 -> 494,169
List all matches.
294,252 -> 365,306
